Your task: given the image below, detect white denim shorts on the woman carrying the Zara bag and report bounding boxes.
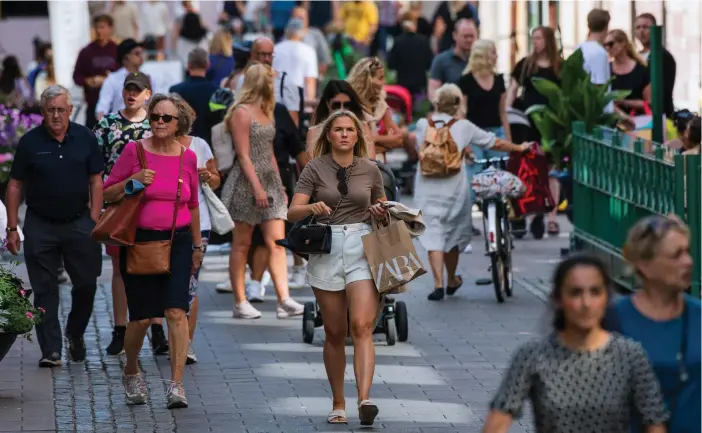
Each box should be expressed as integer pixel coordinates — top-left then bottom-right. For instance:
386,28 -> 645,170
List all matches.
307,223 -> 373,292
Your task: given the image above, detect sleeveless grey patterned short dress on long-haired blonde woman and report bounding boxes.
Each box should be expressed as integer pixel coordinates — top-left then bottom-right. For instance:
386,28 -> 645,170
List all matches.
222,107 -> 288,225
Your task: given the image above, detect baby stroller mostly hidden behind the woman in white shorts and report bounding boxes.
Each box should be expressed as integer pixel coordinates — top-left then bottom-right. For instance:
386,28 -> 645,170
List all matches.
302,161 -> 409,346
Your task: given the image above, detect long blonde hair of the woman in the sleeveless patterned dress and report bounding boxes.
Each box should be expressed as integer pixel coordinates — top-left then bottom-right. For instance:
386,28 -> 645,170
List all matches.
224,62 -> 275,125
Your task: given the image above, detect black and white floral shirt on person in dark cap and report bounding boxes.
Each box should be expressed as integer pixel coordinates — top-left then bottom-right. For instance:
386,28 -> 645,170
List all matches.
93,111 -> 151,179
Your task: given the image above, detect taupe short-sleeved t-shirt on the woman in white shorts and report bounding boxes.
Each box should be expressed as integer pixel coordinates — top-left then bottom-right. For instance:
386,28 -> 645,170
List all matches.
295,153 -> 385,225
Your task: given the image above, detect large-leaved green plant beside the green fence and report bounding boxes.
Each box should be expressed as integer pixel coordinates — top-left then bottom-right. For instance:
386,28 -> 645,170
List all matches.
527,49 -> 631,168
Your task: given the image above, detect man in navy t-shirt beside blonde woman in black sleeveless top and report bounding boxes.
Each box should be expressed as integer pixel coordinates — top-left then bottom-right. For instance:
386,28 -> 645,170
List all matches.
428,18 -> 478,100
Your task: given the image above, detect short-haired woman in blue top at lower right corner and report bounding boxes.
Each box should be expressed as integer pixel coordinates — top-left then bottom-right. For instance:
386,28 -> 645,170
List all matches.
607,215 -> 702,433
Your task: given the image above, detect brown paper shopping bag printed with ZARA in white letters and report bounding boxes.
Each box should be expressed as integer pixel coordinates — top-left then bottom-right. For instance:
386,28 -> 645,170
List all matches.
361,221 -> 427,293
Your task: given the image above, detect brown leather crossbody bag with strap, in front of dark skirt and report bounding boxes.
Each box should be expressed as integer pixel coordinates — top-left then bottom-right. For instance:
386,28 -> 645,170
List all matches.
127,146 -> 186,275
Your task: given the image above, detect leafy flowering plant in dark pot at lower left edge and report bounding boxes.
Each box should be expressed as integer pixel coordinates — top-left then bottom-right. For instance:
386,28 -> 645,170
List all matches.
0,250 -> 44,361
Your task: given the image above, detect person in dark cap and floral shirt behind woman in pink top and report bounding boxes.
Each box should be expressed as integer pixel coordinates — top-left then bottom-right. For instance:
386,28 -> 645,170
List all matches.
93,72 -> 168,355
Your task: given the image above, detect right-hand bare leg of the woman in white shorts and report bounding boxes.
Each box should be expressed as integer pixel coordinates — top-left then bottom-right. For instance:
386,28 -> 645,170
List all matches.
346,280 -> 380,403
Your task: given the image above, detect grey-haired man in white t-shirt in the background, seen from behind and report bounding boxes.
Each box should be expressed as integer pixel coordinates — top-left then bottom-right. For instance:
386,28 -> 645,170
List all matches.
273,18 -> 319,101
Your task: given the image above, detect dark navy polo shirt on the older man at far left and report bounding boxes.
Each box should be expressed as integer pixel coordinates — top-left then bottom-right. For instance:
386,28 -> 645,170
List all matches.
10,122 -> 104,221
